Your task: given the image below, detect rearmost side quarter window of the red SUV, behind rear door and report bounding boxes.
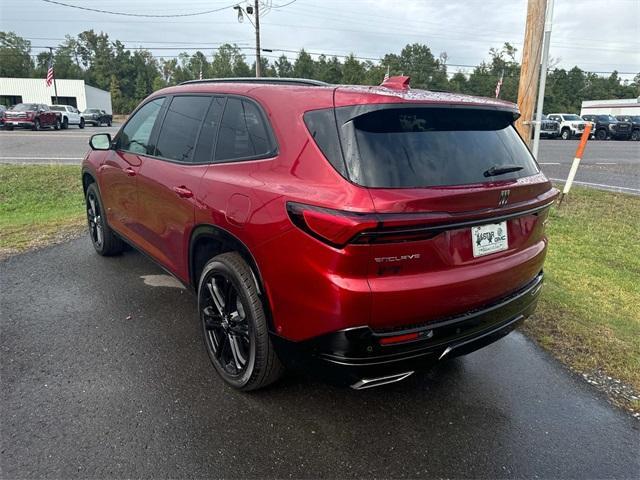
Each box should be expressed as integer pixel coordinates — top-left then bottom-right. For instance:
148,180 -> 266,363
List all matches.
215,97 -> 274,162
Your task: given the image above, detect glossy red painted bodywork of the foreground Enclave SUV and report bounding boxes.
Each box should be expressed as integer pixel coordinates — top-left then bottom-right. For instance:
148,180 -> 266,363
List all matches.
83,79 -> 557,372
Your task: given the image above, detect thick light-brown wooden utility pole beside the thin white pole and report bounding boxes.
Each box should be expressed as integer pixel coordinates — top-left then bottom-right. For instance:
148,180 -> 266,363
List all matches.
516,0 -> 547,145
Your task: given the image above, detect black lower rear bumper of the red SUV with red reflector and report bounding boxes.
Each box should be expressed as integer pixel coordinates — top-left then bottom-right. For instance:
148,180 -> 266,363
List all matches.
273,272 -> 543,385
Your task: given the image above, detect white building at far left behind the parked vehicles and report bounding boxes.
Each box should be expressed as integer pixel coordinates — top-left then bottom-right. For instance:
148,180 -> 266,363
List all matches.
0,77 -> 113,113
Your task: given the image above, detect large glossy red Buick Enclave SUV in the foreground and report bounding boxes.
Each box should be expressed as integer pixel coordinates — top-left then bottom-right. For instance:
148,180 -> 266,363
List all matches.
82,77 -> 558,390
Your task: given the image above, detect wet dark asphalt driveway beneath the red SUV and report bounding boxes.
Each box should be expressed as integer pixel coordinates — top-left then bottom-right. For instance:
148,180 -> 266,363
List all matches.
0,238 -> 640,478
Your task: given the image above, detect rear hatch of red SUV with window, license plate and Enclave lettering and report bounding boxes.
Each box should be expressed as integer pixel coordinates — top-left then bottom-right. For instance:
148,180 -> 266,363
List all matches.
304,87 -> 556,330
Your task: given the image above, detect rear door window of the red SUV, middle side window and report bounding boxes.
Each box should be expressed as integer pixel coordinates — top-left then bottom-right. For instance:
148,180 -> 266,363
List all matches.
155,96 -> 211,162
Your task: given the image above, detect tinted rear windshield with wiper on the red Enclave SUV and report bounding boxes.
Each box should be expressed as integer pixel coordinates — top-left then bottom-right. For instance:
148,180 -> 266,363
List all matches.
305,107 -> 538,188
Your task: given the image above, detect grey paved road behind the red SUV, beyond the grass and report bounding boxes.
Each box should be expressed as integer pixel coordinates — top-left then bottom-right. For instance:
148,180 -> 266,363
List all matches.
0,129 -> 640,194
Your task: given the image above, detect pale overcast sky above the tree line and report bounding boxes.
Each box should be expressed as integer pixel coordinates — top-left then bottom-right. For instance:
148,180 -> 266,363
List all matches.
0,0 -> 640,77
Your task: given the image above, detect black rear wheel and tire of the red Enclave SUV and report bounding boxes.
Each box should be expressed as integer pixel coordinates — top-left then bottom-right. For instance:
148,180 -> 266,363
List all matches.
198,252 -> 284,391
